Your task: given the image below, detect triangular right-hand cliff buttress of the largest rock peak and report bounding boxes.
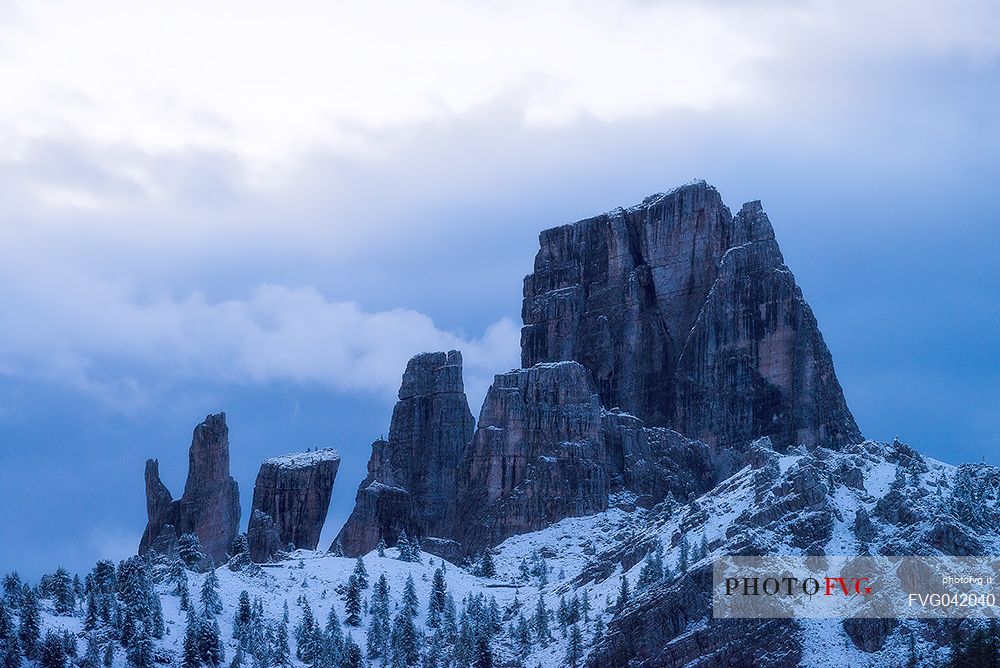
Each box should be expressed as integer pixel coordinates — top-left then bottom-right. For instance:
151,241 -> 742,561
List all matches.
674,202 -> 861,456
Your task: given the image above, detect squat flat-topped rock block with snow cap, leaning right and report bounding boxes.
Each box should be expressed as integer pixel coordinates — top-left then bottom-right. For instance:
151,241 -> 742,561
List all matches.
248,449 -> 340,561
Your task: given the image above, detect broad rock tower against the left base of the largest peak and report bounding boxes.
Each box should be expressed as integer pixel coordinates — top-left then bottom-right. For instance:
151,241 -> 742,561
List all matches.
458,362 -> 610,552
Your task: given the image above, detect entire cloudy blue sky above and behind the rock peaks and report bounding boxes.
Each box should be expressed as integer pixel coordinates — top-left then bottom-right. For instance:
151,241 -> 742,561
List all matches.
0,0 -> 1000,576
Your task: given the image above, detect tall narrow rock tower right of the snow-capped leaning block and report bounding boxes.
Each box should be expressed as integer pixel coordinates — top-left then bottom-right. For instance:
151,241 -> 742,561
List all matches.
339,350 -> 475,556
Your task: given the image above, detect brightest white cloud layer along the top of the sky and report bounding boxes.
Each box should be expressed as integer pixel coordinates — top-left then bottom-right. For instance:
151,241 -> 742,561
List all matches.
0,0 -> 1000,172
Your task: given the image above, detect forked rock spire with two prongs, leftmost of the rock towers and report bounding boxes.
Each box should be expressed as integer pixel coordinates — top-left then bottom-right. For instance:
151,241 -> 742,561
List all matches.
139,413 -> 240,563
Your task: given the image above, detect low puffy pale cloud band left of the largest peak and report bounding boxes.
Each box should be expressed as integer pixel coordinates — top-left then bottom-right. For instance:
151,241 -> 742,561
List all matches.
0,256 -> 518,406
